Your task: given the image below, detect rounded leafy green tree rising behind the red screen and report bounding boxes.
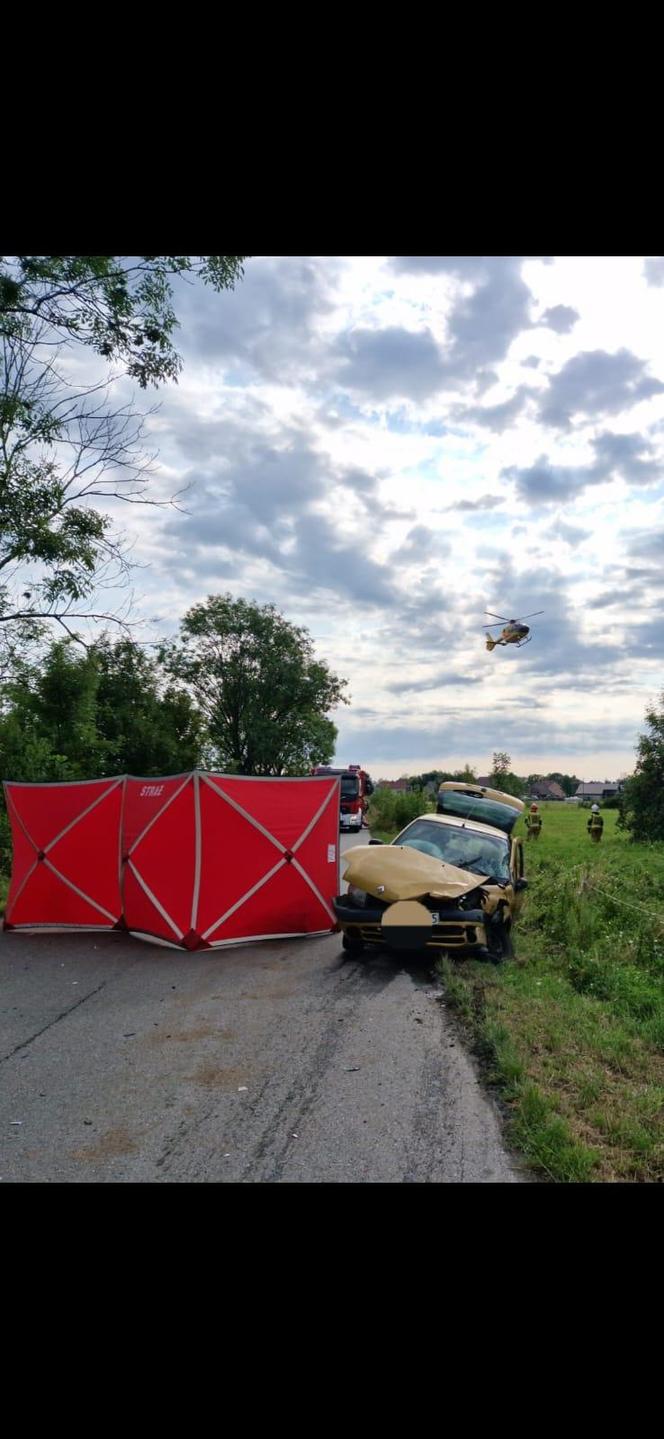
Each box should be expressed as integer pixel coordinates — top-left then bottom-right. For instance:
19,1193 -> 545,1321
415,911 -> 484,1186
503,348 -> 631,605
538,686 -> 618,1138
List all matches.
161,594 -> 347,774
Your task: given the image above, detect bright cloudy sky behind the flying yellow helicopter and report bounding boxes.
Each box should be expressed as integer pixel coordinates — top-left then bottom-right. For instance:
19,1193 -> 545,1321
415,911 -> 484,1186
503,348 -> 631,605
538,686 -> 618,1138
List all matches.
108,256 -> 664,778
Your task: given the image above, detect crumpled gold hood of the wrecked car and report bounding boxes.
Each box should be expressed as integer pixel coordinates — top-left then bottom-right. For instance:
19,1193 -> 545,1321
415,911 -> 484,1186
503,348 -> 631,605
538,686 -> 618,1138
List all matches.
343,845 -> 487,904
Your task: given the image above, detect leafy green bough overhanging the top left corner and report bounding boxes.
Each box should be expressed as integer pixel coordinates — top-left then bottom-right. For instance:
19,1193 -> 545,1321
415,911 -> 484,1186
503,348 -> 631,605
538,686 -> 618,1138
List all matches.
0,255 -> 246,389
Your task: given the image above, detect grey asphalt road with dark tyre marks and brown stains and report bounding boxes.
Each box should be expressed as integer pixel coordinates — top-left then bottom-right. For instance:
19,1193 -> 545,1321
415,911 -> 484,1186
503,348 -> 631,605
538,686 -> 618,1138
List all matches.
0,832 -> 523,1183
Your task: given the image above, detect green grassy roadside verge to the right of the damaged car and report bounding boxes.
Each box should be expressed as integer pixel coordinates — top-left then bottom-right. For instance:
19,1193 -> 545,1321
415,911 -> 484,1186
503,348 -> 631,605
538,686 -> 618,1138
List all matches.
362,804 -> 664,1183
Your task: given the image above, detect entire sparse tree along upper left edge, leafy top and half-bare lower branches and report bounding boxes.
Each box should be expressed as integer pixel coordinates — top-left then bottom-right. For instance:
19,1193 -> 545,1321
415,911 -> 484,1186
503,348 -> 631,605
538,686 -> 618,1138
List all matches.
0,255 -> 243,653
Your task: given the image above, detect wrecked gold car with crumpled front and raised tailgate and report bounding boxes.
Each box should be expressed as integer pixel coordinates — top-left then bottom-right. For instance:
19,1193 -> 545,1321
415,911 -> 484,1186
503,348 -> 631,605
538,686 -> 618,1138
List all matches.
334,780 -> 527,963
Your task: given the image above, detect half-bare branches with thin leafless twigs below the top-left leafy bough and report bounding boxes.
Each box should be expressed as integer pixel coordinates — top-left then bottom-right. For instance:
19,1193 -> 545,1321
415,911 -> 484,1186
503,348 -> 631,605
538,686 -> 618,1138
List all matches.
0,332 -> 151,646
